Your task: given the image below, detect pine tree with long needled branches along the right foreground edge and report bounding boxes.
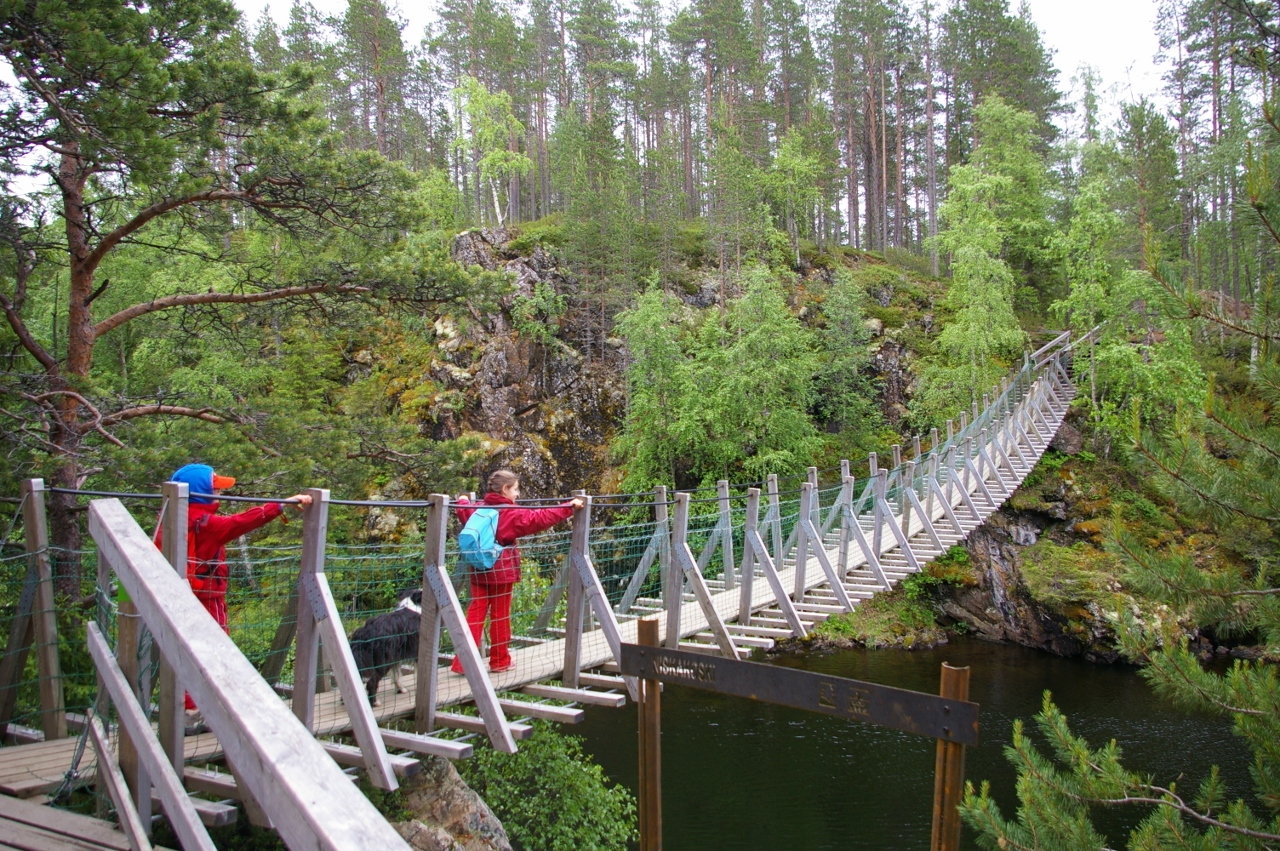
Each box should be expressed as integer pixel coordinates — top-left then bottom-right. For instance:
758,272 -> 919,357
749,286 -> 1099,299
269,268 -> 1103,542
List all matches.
961,19 -> 1280,850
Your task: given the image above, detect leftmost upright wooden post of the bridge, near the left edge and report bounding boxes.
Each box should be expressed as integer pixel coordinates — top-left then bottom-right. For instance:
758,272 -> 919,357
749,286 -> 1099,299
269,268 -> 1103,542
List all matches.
22,479 -> 67,741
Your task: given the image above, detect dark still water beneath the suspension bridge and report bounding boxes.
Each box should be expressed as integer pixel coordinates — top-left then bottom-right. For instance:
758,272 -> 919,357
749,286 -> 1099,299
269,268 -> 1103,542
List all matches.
576,641 -> 1252,851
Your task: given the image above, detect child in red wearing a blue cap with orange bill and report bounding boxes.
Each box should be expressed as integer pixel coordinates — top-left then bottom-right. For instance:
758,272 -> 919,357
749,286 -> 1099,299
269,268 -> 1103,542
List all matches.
156,465 -> 311,710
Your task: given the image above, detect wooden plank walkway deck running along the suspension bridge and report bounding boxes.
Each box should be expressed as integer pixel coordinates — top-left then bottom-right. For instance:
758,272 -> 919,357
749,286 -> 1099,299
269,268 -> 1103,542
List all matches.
0,350 -> 1075,797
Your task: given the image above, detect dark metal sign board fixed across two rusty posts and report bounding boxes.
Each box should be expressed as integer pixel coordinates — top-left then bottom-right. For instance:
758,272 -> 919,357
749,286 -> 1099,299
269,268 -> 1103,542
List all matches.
618,644 -> 978,746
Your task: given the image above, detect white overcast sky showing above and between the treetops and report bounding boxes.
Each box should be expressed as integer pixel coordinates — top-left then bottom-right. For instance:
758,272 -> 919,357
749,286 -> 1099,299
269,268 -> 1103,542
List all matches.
234,0 -> 1164,129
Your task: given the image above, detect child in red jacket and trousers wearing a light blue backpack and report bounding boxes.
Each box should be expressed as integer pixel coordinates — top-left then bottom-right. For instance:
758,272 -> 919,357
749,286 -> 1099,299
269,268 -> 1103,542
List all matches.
449,470 -> 585,673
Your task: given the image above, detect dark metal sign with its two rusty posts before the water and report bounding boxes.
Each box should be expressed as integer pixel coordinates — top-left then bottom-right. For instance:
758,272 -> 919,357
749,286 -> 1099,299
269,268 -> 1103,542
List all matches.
618,619 -> 978,851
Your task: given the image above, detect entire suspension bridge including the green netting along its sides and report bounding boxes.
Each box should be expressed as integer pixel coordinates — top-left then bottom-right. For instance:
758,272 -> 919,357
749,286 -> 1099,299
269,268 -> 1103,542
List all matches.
0,334 -> 1075,850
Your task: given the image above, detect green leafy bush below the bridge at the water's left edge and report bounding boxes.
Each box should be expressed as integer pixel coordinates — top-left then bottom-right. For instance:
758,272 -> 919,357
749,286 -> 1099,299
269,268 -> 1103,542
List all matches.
457,722 -> 637,851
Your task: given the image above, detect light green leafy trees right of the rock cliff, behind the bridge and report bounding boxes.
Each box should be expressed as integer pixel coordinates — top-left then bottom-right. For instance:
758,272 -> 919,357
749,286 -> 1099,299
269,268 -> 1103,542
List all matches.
614,267 -> 817,489
